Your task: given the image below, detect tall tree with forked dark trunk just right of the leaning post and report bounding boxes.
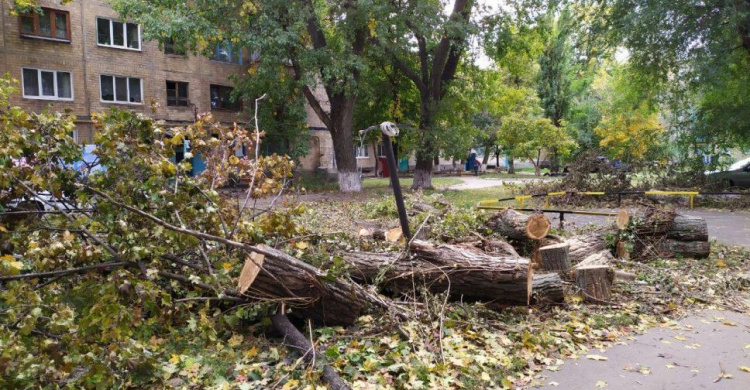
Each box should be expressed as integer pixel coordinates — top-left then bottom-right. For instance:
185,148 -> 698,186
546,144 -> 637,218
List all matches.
373,0 -> 475,189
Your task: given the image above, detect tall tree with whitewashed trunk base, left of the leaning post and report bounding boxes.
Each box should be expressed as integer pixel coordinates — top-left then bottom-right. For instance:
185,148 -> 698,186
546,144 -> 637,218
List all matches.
112,0 -> 372,192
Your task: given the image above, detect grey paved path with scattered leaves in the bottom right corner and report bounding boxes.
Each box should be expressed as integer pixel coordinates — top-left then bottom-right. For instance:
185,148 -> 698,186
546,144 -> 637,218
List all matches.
542,311 -> 750,390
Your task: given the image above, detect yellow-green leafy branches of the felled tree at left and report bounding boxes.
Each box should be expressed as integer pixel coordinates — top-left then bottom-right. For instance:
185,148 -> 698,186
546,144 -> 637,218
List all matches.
0,74 -> 301,388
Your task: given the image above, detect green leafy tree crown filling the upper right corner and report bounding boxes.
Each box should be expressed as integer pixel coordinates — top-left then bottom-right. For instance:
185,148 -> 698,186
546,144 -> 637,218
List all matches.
596,0 -> 750,152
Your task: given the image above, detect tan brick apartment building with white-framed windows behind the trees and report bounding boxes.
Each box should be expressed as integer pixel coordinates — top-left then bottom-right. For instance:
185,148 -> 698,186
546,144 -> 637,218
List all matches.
0,0 -> 334,171
